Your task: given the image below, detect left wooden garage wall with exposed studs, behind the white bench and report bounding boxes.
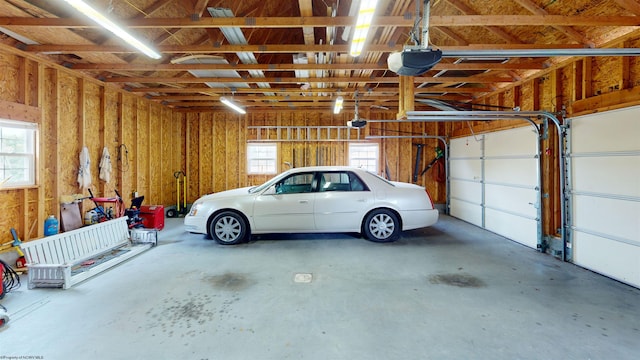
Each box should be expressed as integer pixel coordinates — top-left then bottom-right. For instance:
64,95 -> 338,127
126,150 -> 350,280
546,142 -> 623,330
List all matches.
0,51 -> 186,243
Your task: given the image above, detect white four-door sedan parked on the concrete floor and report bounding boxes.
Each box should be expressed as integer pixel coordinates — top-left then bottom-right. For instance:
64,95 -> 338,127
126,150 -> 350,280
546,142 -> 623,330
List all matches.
184,166 -> 438,244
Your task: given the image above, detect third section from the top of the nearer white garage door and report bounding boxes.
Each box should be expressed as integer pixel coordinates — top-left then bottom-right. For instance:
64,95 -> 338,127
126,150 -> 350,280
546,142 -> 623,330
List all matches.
573,196 -> 640,243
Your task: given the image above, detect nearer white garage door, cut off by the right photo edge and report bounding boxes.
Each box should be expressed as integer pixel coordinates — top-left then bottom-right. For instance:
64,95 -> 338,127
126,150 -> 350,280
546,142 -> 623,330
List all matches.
569,107 -> 640,287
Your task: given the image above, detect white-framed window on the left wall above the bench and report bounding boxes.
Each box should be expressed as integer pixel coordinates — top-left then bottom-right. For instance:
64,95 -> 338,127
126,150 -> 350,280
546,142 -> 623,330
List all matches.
0,119 -> 38,187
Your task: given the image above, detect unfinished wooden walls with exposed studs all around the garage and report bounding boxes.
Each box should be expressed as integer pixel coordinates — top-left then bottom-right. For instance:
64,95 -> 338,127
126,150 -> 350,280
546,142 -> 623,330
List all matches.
0,40 -> 640,248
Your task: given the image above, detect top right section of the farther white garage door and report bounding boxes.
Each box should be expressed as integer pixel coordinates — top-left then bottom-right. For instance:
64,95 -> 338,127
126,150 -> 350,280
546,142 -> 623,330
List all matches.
484,126 -> 537,157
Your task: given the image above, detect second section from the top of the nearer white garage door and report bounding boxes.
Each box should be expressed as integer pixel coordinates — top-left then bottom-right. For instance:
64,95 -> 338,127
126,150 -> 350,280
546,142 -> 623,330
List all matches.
571,156 -> 640,197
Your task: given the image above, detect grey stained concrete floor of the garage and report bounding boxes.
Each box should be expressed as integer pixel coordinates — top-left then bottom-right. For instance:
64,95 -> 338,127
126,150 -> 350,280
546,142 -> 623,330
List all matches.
0,216 -> 640,360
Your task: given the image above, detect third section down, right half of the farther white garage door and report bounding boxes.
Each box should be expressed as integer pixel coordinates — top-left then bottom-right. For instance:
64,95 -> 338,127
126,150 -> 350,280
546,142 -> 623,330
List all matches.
485,184 -> 538,218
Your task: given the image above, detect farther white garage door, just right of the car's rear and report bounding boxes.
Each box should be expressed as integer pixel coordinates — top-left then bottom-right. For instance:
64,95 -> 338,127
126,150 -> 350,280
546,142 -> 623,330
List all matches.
449,126 -> 542,249
